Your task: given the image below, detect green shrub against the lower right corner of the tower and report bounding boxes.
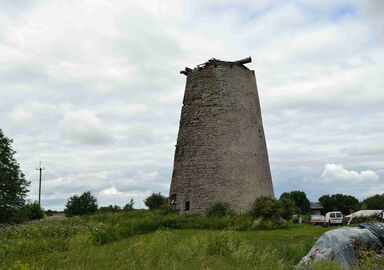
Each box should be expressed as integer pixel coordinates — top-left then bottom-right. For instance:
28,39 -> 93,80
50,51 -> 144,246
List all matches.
250,196 -> 282,219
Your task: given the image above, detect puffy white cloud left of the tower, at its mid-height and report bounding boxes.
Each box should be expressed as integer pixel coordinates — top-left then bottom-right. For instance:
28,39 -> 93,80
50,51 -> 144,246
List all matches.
60,110 -> 111,144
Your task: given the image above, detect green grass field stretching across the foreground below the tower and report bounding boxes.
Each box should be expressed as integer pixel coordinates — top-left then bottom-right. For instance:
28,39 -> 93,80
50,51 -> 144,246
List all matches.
0,211 -> 380,269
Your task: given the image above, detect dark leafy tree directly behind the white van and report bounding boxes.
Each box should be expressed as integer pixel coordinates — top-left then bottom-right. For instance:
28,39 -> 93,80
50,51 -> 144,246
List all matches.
319,194 -> 360,215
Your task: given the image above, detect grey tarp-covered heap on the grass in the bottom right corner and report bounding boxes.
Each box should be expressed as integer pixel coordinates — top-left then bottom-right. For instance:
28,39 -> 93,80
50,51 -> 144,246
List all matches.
296,223 -> 384,269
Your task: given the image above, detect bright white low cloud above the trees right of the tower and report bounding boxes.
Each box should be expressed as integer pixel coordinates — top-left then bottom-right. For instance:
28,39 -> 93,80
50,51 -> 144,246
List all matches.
321,164 -> 379,184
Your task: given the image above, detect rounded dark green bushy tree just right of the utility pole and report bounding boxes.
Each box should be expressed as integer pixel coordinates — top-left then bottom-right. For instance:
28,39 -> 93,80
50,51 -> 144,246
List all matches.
64,191 -> 97,217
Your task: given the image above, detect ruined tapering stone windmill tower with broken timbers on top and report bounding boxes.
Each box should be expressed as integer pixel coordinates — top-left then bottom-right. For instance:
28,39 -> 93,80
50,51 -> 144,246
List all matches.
170,57 -> 273,213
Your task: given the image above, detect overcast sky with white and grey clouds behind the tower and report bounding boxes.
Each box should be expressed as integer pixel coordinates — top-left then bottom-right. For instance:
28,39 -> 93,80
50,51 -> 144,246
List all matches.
0,0 -> 384,209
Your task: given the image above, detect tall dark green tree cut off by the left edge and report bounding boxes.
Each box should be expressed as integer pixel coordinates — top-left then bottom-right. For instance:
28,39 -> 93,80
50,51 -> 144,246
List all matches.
0,129 -> 30,223
